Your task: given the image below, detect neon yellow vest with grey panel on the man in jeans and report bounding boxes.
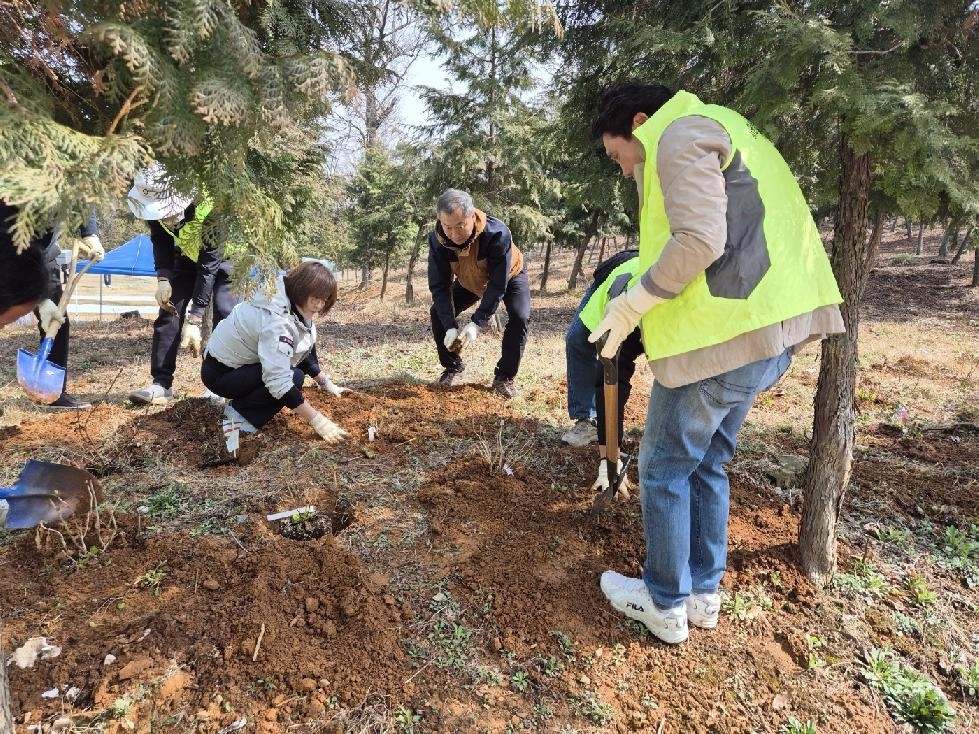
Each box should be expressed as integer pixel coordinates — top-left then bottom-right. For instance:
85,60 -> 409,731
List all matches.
633,92 -> 843,359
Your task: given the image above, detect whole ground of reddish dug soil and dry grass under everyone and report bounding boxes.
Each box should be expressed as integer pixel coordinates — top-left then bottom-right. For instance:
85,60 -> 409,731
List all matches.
0,231 -> 979,734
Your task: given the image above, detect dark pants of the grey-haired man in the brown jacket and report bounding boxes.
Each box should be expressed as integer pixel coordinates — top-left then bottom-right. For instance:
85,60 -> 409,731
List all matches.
431,271 -> 530,380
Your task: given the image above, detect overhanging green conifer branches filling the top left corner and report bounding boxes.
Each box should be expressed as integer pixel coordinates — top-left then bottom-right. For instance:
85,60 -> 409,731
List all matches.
0,0 -> 556,268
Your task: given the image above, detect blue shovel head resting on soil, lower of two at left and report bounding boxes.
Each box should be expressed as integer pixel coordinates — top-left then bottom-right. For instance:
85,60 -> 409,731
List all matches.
0,459 -> 102,530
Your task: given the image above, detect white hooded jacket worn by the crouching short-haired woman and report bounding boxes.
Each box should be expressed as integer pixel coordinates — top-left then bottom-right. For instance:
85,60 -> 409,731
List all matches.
205,275 -> 316,398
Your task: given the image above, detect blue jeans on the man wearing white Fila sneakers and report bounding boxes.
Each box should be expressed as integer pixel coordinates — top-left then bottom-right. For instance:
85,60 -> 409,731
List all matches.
639,349 -> 792,609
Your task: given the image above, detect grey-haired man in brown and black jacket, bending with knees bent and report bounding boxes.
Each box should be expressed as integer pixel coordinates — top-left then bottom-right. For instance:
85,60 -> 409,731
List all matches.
428,189 -> 530,398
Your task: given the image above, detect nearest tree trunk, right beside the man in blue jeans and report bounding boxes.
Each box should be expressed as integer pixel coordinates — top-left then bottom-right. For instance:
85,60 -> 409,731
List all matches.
799,136 -> 883,587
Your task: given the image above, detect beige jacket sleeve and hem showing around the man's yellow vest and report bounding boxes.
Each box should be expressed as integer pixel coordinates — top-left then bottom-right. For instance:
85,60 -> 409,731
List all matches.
633,116 -> 845,387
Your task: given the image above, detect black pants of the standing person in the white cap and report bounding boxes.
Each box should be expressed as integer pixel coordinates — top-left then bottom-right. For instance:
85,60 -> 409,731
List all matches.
150,255 -> 238,388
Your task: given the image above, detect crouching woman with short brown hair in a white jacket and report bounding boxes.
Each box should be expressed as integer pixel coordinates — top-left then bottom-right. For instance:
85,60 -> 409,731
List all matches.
201,262 -> 347,443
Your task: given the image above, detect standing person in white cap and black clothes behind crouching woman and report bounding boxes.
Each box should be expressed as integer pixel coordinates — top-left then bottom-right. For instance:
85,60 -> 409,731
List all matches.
127,163 -> 238,405
